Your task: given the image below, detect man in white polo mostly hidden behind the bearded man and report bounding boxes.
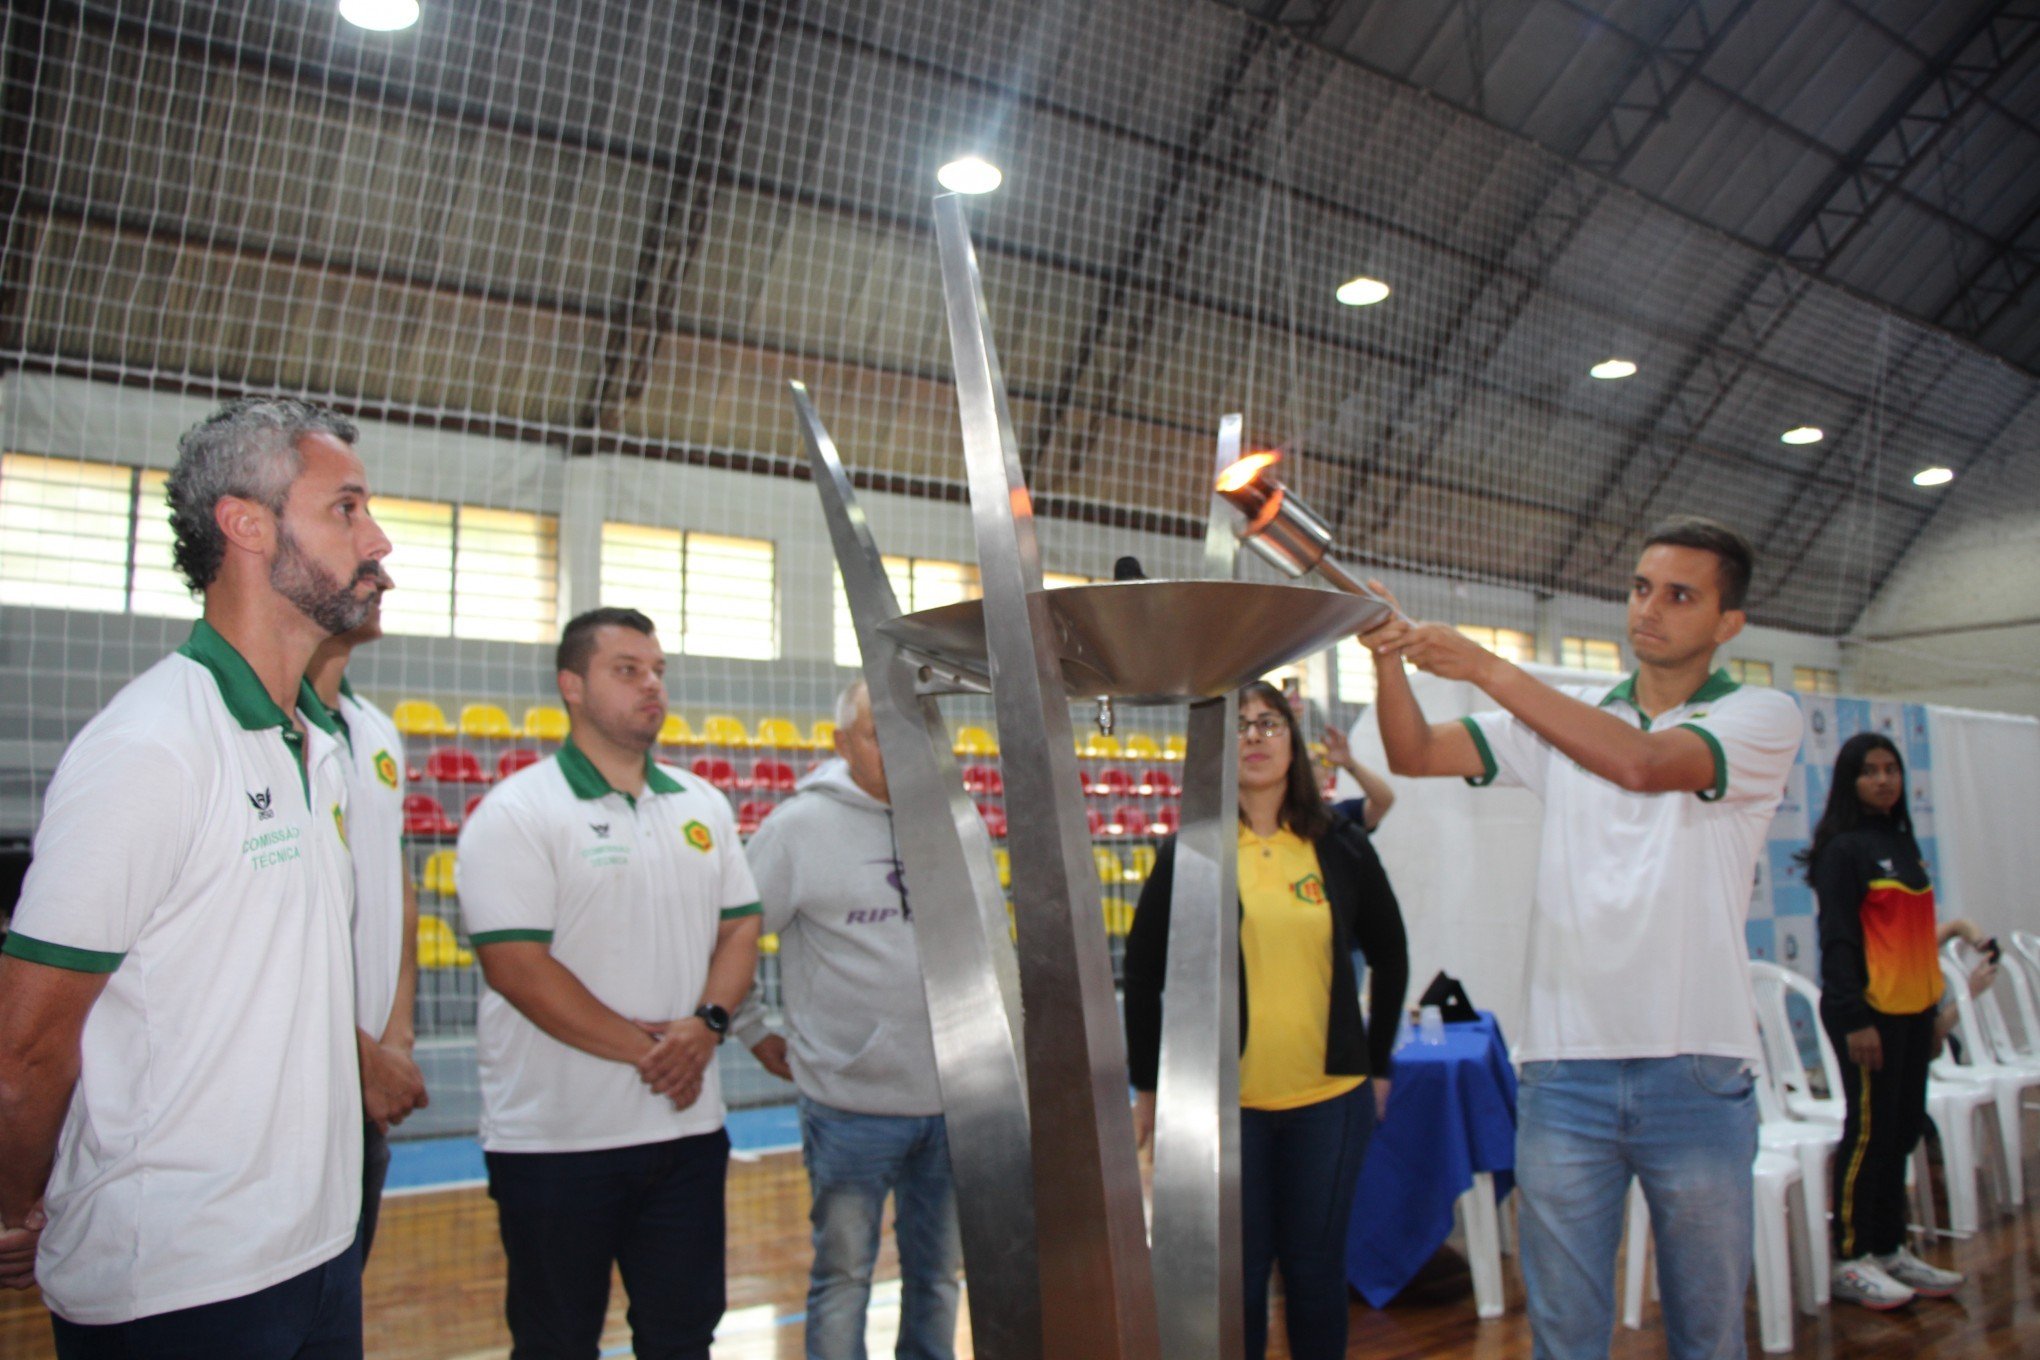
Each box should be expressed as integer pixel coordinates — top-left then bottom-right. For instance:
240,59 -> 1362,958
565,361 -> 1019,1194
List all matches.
304,577 -> 428,1268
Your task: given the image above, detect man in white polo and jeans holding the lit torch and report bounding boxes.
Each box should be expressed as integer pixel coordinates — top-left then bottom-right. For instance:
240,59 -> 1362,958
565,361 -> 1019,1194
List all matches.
1361,518 -> 1801,1360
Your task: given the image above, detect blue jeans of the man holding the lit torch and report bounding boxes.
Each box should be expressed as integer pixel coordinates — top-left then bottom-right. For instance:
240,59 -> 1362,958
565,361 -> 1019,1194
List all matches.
1516,1054 -> 1756,1360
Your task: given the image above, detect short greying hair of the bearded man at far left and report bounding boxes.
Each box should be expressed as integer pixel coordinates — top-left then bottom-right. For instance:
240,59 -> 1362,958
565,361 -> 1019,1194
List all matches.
167,398 -> 361,589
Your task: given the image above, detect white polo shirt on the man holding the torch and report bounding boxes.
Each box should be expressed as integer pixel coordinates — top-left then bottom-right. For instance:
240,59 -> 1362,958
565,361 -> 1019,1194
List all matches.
1461,671 -> 1801,1062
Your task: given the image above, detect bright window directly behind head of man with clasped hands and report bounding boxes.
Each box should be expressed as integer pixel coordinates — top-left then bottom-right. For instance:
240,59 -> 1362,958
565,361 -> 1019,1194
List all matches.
602,520 -> 779,661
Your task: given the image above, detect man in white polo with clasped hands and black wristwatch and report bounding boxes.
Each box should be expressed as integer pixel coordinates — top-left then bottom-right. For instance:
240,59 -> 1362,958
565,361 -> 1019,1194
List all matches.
457,608 -> 759,1360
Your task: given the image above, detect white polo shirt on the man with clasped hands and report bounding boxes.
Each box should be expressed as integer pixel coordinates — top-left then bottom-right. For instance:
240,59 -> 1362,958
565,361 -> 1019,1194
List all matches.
457,740 -> 759,1152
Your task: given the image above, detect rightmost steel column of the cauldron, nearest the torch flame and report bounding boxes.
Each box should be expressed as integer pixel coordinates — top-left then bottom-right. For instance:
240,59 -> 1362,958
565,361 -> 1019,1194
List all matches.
1153,416 -> 1246,1360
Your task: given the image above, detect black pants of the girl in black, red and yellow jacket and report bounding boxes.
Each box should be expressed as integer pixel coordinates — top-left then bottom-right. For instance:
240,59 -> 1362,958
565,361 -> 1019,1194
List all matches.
1822,1011 -> 1934,1260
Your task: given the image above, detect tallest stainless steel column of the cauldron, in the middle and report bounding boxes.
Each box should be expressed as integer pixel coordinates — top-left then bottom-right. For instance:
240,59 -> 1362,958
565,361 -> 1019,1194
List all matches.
934,196 -> 1161,1360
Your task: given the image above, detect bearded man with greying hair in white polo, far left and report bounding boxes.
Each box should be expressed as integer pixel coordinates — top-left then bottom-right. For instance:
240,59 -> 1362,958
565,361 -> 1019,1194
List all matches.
0,400 -> 390,1360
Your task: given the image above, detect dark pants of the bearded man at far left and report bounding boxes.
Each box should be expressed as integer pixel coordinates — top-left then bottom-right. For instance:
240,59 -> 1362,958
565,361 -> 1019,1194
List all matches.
49,1246 -> 361,1360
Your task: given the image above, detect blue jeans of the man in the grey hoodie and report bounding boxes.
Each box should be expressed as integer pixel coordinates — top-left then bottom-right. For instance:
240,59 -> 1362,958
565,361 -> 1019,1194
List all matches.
800,1095 -> 963,1360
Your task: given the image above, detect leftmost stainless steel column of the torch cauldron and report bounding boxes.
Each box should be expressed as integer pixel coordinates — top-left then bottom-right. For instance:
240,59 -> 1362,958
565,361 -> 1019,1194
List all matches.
792,383 -> 1036,1360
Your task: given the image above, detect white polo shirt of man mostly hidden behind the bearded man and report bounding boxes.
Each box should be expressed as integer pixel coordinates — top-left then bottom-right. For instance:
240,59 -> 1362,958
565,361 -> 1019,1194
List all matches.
300,677 -> 408,1038
